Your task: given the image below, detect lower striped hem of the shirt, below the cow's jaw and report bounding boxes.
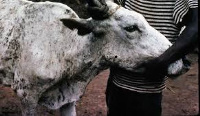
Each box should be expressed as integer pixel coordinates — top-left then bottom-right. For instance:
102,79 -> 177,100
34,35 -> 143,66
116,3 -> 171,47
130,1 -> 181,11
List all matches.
110,68 -> 167,93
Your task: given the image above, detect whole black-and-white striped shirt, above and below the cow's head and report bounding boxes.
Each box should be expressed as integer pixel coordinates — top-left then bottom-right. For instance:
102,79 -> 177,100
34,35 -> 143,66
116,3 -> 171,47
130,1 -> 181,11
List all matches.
110,0 -> 198,93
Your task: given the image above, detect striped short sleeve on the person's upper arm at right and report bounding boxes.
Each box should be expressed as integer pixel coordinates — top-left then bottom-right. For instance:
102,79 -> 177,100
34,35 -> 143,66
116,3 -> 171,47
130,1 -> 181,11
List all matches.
173,0 -> 198,24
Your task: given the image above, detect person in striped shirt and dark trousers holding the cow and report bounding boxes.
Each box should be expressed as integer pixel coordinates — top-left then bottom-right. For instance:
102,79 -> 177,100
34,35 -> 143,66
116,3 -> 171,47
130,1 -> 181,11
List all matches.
88,0 -> 198,116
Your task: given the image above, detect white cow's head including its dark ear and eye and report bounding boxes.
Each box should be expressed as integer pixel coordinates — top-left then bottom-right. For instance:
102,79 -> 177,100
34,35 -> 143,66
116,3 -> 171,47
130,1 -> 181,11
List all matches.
61,2 -> 183,73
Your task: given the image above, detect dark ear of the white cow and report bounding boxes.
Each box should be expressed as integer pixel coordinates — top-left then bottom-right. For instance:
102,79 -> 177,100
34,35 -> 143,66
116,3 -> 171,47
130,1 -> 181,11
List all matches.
60,18 -> 92,35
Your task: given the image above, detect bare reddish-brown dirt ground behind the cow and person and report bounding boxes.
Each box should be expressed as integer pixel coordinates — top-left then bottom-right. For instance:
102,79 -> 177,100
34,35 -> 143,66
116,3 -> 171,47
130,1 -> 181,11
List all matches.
0,54 -> 199,116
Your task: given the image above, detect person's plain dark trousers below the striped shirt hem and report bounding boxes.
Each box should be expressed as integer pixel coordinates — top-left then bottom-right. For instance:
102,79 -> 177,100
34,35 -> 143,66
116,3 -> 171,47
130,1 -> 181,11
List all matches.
106,77 -> 162,116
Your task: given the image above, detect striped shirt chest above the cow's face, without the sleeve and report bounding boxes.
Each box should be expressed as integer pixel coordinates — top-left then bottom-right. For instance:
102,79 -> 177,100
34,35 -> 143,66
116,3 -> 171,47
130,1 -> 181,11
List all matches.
125,0 -> 180,41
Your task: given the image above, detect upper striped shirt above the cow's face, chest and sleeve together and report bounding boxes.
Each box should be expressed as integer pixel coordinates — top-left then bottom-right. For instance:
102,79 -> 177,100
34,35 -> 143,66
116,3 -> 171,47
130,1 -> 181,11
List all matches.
115,0 -> 198,42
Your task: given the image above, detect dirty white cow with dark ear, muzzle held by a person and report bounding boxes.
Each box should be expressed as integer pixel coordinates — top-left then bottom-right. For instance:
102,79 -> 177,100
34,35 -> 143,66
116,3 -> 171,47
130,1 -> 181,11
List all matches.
0,0 -> 182,116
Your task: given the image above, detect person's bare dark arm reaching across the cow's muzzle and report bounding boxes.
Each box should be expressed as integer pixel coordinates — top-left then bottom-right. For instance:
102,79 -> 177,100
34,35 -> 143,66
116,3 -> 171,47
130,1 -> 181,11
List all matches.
157,8 -> 198,65
